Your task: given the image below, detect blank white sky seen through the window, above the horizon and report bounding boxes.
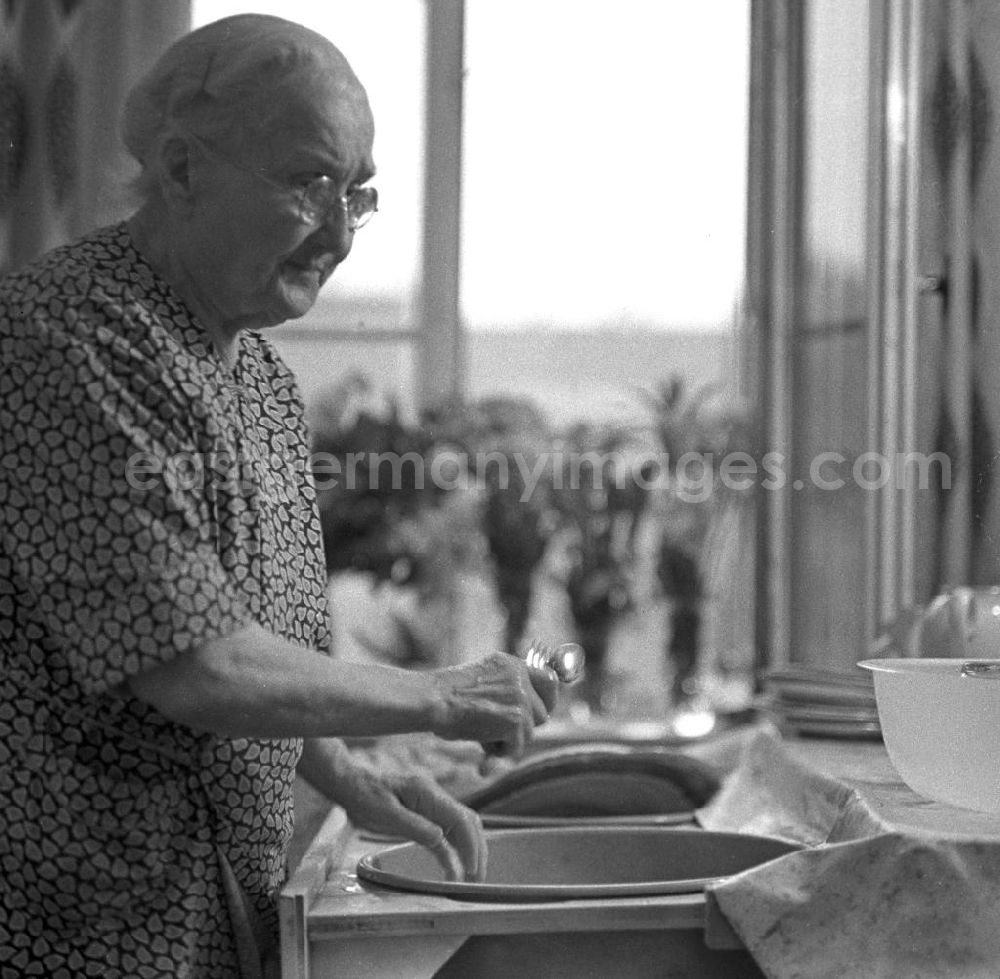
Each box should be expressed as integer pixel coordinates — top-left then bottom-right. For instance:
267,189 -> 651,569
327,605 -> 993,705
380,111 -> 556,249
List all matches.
193,0 -> 749,328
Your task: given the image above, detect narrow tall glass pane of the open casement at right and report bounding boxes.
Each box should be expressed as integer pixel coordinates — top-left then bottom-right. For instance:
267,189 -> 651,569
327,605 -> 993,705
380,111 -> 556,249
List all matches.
788,0 -> 881,670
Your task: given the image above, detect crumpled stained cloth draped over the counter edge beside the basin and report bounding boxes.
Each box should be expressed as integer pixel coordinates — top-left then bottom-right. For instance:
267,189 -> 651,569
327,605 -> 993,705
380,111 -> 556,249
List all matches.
698,731 -> 1000,979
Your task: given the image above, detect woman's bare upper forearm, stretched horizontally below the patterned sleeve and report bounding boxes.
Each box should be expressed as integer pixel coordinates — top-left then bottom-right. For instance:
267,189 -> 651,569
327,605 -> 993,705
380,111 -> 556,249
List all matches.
122,625 -> 444,738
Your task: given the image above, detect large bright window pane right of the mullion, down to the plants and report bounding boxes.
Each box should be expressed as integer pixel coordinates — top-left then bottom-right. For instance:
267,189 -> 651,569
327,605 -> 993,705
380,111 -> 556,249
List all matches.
462,0 -> 749,422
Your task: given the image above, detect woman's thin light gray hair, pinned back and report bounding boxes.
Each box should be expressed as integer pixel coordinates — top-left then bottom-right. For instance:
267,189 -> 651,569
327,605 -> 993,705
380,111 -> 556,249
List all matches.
121,14 -> 361,199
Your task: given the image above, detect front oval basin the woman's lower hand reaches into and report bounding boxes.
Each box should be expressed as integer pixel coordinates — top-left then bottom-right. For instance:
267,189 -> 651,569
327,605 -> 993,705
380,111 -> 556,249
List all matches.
358,826 -> 800,901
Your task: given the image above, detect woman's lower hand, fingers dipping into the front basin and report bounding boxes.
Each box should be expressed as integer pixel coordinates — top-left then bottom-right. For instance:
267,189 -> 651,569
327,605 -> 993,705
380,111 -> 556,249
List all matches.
335,768 -> 486,881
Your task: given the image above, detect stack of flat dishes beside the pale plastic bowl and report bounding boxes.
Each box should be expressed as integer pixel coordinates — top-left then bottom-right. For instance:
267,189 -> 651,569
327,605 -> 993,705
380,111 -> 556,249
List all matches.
758,665 -> 882,738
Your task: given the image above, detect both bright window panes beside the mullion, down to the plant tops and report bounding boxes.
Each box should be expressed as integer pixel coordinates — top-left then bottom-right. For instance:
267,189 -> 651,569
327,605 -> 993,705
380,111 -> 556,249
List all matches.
193,0 -> 749,411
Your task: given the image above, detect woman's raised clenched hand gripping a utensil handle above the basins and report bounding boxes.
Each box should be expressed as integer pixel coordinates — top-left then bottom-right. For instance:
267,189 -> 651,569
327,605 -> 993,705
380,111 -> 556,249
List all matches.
430,653 -> 558,758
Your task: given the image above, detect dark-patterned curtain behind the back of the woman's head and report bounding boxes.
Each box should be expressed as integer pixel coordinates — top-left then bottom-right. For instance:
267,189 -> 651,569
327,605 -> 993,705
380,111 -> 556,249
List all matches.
0,0 -> 191,271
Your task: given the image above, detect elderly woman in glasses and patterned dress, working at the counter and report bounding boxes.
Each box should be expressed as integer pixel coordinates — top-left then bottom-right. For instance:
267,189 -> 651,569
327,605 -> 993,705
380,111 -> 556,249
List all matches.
0,15 -> 554,979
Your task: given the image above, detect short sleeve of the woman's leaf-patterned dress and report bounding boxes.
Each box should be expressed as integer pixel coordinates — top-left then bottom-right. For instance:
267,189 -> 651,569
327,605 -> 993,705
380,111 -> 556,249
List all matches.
0,318 -> 250,693
